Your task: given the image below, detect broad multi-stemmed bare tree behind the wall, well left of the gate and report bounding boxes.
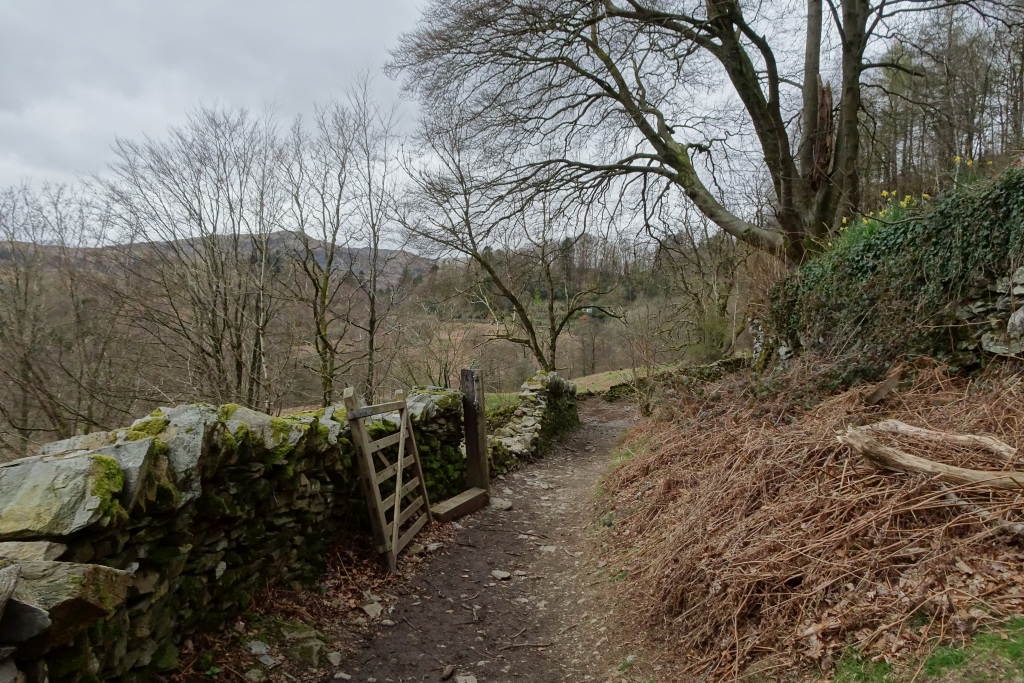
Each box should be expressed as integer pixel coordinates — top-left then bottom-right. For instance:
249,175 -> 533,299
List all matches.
96,109 -> 285,407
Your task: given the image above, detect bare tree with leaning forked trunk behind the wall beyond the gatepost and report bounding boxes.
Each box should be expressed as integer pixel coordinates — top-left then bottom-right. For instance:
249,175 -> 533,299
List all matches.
404,109 -> 615,371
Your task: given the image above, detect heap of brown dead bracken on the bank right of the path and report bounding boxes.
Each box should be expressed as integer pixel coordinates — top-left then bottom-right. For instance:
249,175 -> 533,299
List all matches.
608,364 -> 1024,676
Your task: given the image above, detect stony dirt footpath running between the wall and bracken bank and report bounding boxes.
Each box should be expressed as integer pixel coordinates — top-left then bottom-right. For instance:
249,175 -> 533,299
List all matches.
348,399 -> 633,683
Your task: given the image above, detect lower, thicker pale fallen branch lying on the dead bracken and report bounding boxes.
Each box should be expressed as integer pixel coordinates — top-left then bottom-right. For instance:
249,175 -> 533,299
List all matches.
837,421 -> 1024,489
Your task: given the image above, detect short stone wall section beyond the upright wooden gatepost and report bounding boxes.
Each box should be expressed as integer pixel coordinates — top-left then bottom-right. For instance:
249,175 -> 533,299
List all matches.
489,372 -> 580,474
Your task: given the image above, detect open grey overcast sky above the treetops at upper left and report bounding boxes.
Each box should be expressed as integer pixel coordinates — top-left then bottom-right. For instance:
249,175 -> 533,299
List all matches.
0,0 -> 422,187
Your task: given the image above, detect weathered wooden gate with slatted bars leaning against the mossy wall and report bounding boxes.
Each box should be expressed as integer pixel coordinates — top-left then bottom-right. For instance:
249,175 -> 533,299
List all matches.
344,388 -> 433,571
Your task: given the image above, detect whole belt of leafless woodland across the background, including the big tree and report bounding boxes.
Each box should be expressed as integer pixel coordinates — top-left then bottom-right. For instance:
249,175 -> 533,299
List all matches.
0,0 -> 1024,466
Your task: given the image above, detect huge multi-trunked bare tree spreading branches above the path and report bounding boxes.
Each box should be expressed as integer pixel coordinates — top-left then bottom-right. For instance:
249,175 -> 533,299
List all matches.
390,0 -> 1021,263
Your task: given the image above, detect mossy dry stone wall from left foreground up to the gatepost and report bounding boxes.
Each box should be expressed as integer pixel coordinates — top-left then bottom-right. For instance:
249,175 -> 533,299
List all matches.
0,388 -> 465,683
